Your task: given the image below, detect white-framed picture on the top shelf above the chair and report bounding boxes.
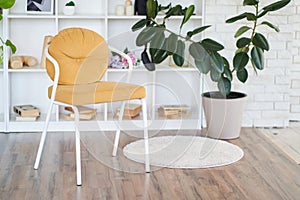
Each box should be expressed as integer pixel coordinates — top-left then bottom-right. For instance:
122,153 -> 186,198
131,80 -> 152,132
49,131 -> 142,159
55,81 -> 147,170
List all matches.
26,0 -> 54,14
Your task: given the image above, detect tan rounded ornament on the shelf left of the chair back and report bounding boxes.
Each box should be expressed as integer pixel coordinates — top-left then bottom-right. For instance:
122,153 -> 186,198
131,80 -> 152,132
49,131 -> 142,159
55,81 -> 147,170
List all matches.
9,56 -> 37,69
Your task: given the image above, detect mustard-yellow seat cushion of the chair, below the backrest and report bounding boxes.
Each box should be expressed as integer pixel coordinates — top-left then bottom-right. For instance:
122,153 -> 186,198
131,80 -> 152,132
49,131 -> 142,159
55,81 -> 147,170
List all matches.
48,81 -> 146,105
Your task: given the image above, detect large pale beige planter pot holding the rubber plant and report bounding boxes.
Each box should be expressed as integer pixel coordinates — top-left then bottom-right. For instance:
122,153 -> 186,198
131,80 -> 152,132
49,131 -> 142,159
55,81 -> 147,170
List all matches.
202,92 -> 247,139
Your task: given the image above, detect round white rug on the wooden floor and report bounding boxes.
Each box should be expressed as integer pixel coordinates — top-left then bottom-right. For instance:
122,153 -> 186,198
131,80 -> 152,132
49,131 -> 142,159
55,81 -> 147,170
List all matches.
123,135 -> 244,168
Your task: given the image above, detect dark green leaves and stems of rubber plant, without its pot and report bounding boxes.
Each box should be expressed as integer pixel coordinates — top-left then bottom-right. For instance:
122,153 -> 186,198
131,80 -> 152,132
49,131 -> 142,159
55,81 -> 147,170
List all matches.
132,0 -> 291,97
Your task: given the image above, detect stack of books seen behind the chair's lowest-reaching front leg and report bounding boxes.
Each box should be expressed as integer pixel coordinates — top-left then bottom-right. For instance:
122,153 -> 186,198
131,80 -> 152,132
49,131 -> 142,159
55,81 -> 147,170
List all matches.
64,106 -> 97,120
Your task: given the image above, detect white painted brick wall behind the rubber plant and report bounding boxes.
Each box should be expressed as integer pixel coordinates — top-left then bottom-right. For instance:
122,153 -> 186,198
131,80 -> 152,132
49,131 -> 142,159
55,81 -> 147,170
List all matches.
205,0 -> 292,127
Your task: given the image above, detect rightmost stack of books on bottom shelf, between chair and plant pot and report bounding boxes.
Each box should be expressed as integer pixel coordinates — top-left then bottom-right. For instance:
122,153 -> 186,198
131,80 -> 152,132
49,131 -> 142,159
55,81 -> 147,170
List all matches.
158,105 -> 190,119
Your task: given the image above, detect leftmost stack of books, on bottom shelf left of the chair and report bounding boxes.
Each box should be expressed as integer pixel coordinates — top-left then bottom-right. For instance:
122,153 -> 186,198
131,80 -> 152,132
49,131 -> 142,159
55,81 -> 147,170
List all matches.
13,105 -> 40,121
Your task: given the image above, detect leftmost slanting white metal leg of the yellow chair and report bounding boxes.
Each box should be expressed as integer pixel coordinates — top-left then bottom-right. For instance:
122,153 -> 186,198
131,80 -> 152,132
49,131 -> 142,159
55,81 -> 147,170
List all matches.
33,101 -> 53,169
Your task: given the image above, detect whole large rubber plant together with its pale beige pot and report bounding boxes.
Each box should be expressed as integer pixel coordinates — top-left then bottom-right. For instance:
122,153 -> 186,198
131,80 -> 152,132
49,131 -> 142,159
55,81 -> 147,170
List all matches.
132,0 -> 290,139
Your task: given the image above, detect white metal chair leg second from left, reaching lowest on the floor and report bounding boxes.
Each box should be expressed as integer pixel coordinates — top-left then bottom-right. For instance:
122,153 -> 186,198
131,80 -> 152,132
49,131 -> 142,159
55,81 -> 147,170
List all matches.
73,106 -> 82,186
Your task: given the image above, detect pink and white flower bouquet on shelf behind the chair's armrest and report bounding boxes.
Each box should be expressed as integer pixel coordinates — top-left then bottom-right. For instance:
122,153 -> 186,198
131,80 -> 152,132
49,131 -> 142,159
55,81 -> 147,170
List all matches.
108,48 -> 140,69
